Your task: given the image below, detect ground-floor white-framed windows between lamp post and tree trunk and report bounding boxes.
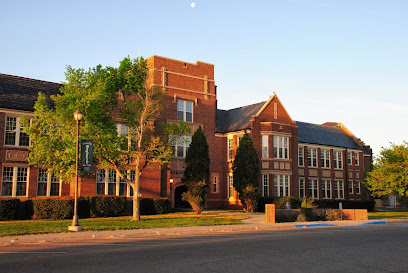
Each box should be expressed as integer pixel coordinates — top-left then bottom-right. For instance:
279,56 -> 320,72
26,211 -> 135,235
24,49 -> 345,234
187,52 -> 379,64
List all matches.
95,169 -> 135,197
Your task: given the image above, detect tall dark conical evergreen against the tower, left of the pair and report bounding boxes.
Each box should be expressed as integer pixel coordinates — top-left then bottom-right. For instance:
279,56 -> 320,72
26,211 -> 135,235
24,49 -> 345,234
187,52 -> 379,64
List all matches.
182,126 -> 210,214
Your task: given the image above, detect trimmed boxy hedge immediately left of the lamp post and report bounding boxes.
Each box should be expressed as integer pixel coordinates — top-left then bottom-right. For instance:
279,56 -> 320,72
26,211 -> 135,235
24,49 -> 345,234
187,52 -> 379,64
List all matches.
32,198 -> 74,220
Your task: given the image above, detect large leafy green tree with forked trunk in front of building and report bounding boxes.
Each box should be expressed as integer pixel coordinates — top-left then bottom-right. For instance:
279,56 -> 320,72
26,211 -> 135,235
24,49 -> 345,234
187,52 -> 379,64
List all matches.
23,57 -> 187,221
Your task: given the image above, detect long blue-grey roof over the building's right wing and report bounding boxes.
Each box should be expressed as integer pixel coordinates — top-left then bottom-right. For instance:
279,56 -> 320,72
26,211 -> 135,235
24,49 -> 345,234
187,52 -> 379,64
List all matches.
296,121 -> 365,150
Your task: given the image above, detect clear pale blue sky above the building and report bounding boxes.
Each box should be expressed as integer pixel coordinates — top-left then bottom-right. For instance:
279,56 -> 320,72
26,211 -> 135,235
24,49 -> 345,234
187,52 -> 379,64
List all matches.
0,0 -> 408,155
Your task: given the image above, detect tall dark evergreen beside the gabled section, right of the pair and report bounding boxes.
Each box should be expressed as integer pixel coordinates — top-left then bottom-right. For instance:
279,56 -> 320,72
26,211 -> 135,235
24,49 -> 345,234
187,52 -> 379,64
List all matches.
232,133 -> 261,211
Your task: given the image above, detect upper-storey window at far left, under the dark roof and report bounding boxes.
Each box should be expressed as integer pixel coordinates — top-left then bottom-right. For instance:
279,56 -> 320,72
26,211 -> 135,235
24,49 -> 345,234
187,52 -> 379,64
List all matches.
4,117 -> 30,147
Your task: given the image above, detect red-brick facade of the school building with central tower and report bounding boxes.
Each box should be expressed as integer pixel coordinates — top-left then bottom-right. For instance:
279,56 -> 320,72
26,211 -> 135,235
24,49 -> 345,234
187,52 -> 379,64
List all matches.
0,55 -> 371,208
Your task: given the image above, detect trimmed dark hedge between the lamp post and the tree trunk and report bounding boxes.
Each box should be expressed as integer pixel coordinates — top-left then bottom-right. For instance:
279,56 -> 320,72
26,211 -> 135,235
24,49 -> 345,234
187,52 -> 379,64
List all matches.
86,196 -> 127,217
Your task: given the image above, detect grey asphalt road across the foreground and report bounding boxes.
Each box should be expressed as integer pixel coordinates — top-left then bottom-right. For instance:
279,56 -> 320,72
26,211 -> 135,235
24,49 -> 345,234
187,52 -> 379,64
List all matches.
0,224 -> 408,273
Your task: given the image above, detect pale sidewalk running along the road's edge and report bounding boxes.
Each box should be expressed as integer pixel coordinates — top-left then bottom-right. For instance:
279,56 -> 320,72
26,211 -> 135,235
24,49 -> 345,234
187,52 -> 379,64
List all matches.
0,213 -> 408,246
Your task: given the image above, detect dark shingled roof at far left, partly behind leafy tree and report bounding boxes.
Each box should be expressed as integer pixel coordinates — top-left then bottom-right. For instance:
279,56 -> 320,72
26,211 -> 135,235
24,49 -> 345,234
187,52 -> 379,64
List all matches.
0,74 -> 63,112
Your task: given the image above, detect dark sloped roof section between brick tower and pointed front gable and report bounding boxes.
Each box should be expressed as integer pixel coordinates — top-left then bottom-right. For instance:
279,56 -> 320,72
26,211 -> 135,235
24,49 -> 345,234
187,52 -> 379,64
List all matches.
215,101 -> 266,133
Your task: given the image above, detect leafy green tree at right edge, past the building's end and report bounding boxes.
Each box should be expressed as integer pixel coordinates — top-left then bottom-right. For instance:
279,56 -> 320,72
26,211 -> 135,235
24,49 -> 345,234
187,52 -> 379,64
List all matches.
364,142 -> 408,197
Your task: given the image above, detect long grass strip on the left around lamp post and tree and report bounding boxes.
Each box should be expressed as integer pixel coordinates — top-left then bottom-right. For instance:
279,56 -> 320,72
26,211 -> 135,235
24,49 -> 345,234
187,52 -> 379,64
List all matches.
0,212 -> 248,237
